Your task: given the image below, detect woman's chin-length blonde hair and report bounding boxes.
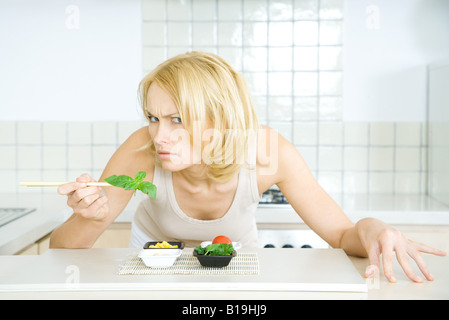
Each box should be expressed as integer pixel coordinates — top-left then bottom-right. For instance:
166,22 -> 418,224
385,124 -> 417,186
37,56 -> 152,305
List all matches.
139,52 -> 259,182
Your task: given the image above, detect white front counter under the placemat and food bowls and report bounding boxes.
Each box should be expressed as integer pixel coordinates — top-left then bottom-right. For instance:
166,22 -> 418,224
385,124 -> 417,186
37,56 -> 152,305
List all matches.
0,249 -> 449,300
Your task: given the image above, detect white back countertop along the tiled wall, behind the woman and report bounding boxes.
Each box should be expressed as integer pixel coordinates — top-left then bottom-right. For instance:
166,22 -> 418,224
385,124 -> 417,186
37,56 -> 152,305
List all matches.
0,192 -> 449,255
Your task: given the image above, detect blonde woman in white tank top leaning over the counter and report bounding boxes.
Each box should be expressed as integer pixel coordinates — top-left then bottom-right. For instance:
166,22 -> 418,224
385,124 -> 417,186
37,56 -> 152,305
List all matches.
50,52 -> 445,282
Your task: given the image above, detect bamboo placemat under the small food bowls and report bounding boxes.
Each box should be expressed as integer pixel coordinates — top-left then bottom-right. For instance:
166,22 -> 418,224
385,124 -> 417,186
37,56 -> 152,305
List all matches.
119,252 -> 259,275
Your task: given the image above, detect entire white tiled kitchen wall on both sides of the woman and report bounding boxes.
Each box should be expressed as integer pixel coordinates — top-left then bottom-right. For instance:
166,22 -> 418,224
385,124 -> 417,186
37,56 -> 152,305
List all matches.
0,0 -> 427,193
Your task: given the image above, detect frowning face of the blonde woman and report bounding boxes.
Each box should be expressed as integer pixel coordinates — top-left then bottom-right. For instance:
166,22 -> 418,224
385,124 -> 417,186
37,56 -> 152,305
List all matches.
146,82 -> 201,171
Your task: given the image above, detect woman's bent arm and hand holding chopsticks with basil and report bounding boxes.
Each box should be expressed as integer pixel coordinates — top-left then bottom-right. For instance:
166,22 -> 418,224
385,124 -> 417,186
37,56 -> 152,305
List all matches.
50,127 -> 153,248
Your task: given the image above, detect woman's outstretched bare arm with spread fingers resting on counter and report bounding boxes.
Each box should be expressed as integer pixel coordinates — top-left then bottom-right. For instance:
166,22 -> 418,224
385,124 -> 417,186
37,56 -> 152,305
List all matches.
259,129 -> 445,282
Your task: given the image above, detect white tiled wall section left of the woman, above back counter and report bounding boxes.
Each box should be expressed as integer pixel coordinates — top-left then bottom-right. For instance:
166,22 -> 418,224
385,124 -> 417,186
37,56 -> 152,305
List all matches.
0,121 -> 144,192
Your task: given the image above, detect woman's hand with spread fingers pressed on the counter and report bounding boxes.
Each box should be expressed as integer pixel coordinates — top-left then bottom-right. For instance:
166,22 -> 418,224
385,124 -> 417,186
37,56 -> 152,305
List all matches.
356,218 -> 446,282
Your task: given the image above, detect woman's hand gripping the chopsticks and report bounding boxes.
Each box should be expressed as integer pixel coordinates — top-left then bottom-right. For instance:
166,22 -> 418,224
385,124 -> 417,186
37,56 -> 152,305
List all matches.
58,174 -> 109,220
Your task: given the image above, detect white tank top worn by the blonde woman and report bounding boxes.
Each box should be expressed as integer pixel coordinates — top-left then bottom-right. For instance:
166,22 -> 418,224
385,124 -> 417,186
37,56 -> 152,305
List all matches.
134,152 -> 260,248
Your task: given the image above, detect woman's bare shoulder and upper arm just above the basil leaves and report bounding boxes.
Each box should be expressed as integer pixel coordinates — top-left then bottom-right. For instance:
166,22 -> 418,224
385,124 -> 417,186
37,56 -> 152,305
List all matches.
101,127 -> 154,182
